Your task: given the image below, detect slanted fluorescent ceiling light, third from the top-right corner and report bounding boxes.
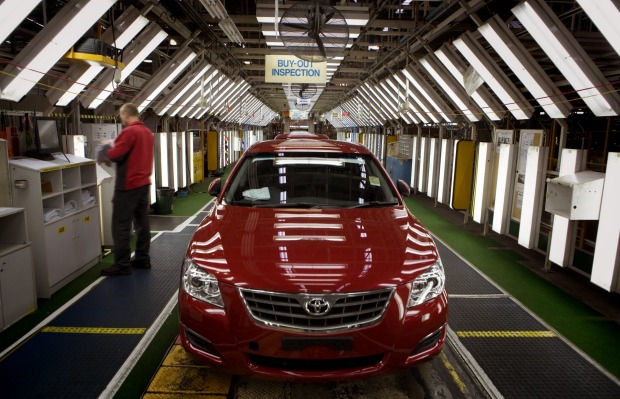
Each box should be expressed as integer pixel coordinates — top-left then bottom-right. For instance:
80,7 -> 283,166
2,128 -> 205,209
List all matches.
478,14 -> 572,119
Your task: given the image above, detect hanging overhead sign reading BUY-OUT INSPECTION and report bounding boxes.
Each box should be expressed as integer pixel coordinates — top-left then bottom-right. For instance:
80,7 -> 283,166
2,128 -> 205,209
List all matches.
265,55 -> 327,84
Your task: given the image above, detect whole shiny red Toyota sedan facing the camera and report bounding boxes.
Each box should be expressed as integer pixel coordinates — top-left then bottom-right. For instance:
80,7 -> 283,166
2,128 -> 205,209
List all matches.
179,134 -> 448,380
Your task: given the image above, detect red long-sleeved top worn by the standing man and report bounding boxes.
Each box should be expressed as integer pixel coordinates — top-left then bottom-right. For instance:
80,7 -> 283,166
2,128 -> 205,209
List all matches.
107,121 -> 155,191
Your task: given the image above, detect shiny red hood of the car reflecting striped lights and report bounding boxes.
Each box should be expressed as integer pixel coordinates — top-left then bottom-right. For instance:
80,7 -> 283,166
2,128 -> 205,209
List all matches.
188,205 -> 438,292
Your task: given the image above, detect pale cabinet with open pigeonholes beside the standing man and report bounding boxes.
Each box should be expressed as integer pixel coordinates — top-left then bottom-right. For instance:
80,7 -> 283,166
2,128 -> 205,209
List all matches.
10,154 -> 101,298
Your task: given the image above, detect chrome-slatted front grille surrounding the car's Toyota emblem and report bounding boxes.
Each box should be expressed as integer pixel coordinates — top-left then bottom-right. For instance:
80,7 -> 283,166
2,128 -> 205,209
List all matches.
239,288 -> 394,333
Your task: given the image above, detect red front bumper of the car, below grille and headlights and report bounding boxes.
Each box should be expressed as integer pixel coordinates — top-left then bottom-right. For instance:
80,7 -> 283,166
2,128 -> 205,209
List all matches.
179,286 -> 448,381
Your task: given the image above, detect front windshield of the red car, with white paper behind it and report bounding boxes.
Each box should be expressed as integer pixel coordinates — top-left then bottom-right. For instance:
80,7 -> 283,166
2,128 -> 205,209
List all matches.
224,153 -> 399,208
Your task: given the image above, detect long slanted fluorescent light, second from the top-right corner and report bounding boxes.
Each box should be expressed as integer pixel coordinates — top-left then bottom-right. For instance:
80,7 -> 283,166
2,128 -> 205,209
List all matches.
512,0 -> 620,116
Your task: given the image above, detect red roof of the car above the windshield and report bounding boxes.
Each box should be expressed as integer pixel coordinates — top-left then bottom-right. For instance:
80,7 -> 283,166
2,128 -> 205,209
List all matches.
248,135 -> 370,154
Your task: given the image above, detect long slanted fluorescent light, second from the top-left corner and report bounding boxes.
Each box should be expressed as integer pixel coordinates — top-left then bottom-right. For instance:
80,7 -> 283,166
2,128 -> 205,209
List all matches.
0,0 -> 116,101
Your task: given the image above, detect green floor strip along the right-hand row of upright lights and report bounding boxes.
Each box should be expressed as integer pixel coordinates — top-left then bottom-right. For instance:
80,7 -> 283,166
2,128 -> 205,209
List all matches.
406,197 -> 620,378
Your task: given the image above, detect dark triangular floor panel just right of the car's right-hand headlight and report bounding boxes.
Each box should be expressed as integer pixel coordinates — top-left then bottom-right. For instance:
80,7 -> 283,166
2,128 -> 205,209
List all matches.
435,240 -> 502,295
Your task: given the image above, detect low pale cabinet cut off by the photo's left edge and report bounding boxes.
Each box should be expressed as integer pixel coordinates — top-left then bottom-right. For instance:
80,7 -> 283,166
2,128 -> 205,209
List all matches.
0,208 -> 37,331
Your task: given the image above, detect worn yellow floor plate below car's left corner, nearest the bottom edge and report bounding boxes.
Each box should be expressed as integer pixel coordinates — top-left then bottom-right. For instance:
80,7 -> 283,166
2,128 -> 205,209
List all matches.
147,366 -> 232,395
